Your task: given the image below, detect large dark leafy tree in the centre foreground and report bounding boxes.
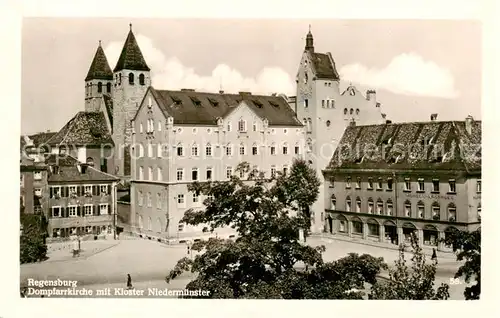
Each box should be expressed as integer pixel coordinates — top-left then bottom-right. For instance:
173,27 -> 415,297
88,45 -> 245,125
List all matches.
166,160 -> 386,299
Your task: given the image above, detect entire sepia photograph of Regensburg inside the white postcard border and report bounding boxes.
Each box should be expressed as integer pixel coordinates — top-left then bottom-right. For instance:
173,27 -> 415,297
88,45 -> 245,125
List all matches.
7,1 -> 492,317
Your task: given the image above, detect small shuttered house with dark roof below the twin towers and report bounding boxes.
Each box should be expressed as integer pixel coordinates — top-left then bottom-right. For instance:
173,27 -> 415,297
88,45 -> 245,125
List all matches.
45,155 -> 119,239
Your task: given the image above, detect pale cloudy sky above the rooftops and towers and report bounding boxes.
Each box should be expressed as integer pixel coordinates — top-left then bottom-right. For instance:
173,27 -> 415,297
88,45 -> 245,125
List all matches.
21,18 -> 482,134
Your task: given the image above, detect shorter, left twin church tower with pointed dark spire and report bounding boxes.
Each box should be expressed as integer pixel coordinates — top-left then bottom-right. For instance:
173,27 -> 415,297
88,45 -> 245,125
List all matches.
85,41 -> 113,112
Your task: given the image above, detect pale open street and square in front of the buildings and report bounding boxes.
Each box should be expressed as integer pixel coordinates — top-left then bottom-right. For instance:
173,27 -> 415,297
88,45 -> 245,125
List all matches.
21,237 -> 465,299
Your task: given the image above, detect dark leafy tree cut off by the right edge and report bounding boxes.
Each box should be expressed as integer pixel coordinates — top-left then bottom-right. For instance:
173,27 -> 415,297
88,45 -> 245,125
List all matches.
443,228 -> 481,300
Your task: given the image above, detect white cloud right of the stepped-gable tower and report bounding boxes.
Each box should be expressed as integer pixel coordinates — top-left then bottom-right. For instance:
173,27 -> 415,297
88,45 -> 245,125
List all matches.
340,53 -> 458,99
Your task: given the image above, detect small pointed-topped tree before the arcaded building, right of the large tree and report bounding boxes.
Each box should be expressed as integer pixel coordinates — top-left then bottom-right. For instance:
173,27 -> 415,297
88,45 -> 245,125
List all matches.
370,235 -> 450,300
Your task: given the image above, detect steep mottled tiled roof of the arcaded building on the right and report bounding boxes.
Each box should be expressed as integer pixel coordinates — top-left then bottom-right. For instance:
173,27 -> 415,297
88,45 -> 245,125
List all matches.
326,120 -> 481,172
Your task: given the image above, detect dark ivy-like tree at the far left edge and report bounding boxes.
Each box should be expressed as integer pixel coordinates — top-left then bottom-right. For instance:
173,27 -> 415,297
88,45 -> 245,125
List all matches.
20,213 -> 47,264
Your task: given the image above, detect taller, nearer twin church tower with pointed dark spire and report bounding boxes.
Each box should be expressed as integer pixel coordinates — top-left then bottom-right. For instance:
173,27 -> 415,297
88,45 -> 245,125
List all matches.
113,24 -> 151,177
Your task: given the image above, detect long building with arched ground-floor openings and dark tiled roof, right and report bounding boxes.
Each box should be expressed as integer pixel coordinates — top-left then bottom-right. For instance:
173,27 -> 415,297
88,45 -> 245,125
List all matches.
323,116 -> 481,250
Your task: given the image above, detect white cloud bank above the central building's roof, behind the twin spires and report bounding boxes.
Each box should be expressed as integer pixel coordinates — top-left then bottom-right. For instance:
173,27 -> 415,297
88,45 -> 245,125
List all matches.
105,34 -> 295,95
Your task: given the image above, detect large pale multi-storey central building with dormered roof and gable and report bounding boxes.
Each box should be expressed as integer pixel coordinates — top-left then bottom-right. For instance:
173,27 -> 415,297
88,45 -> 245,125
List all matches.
131,87 -> 304,239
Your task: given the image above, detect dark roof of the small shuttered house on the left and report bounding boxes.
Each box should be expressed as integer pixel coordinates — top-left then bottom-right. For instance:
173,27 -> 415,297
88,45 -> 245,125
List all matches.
47,155 -> 119,183
